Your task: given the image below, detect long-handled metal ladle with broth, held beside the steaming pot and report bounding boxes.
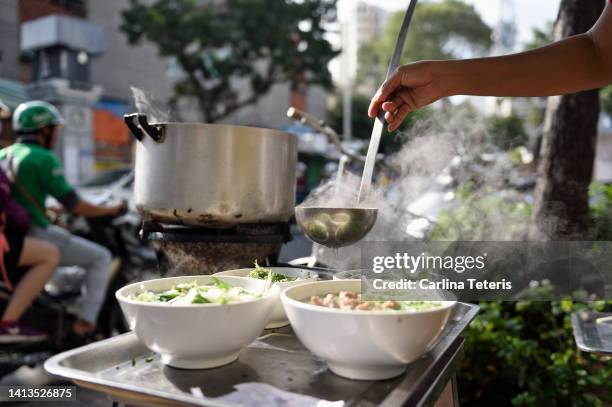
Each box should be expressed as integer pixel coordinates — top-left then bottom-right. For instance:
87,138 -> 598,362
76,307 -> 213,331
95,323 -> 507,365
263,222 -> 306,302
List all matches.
295,0 -> 417,248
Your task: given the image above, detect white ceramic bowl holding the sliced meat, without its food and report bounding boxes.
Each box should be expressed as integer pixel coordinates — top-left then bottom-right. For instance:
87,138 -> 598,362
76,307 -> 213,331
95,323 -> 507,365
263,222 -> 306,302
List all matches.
281,280 -> 456,380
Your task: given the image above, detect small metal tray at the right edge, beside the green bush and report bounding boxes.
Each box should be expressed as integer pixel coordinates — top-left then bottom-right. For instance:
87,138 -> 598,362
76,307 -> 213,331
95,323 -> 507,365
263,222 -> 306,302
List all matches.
572,311 -> 612,356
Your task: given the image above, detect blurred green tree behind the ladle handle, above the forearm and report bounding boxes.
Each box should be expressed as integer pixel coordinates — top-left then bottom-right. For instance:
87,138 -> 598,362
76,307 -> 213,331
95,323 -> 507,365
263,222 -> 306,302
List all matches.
357,0 -> 492,83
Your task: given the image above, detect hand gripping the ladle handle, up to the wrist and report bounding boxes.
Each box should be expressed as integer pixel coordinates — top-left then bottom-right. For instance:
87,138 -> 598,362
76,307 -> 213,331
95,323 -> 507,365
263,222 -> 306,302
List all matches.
368,61 -> 445,131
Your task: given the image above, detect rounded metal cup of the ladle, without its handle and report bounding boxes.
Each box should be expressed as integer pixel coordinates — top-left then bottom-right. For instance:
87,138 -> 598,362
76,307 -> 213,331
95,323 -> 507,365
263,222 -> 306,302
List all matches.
295,206 -> 378,249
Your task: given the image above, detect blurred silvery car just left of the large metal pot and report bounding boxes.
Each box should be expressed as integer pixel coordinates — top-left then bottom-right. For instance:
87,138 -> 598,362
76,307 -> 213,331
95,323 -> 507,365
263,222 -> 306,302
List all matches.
76,167 -> 135,210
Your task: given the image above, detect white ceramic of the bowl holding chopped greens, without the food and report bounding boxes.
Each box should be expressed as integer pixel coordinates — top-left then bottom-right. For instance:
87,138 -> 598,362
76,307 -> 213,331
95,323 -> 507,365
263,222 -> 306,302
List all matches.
115,276 -> 280,369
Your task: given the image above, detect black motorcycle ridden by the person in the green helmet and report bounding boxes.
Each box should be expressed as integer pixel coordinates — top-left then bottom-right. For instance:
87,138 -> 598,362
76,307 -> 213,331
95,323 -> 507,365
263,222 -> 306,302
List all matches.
0,211 -> 159,377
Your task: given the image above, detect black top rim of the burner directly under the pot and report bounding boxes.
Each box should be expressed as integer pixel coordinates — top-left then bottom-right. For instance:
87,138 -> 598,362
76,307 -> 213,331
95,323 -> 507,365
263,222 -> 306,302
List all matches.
143,222 -> 291,244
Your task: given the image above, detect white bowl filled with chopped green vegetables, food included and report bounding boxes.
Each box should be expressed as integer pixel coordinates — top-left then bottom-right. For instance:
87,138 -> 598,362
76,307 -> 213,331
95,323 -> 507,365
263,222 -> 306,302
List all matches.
115,276 -> 280,369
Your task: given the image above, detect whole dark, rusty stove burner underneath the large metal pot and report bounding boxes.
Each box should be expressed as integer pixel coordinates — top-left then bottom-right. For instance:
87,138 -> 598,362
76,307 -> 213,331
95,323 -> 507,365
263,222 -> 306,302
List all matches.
142,222 -> 291,276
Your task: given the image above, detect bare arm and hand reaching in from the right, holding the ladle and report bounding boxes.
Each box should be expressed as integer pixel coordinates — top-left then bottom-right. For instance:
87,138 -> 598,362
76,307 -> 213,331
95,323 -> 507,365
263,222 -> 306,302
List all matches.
368,4 -> 612,131
